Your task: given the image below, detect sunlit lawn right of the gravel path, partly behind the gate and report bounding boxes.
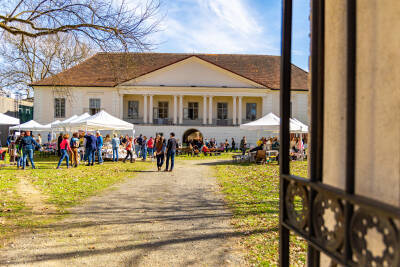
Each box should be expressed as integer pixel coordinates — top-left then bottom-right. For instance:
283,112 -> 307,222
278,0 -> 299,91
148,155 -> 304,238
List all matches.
216,161 -> 307,266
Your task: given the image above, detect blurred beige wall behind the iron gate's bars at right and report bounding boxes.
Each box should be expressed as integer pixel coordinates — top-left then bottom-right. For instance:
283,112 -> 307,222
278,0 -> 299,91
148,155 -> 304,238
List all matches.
321,0 -> 400,266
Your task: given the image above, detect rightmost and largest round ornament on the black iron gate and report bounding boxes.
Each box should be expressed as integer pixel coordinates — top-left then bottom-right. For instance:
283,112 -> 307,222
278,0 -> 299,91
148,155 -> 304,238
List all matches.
350,209 -> 400,267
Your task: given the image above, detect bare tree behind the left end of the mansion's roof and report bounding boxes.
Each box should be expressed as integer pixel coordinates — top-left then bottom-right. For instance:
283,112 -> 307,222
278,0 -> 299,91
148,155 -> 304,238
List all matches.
0,33 -> 94,96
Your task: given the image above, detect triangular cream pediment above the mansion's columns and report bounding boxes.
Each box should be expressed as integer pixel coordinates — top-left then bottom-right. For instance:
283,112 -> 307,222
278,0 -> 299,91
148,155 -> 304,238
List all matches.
120,56 -> 263,88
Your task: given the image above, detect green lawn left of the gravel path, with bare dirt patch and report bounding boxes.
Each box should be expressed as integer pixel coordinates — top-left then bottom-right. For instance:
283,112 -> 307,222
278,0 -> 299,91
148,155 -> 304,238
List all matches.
0,157 -> 150,245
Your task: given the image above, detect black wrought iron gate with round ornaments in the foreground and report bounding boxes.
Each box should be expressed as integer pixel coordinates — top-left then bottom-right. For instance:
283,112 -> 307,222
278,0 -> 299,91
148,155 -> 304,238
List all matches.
279,0 -> 400,266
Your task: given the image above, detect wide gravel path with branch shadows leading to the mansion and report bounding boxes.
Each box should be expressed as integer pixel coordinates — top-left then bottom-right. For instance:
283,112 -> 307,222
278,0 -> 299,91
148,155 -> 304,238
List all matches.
0,161 -> 246,266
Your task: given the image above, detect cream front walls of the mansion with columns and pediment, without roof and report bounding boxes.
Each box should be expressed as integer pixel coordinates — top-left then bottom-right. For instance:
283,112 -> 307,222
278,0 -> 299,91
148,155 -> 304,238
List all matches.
34,57 -> 309,144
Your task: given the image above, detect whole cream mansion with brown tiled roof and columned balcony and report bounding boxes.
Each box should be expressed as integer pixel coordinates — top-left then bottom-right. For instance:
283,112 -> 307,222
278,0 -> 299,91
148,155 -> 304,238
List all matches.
32,53 -> 309,144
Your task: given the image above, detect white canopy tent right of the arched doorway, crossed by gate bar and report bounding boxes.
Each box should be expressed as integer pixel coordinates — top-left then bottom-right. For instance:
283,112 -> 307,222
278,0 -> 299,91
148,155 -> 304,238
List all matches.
240,112 -> 301,132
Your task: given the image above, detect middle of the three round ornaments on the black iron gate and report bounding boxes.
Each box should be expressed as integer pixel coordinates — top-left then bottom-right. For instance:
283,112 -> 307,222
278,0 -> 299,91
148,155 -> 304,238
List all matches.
313,193 -> 344,251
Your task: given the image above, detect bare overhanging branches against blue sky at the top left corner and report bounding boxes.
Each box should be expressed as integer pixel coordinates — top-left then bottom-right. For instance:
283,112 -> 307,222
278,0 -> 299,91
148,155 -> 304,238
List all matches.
0,0 -> 160,51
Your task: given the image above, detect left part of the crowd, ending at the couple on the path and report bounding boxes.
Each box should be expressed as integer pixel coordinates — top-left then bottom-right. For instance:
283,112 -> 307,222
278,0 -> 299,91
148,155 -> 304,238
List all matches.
3,131 -> 178,171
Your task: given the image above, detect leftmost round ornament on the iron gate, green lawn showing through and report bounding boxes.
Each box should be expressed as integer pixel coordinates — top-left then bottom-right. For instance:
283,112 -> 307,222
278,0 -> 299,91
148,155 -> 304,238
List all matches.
285,182 -> 309,229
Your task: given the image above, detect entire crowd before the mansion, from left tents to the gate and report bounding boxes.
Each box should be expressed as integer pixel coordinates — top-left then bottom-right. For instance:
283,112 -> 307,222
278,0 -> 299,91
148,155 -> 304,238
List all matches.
2,131 -> 307,171
